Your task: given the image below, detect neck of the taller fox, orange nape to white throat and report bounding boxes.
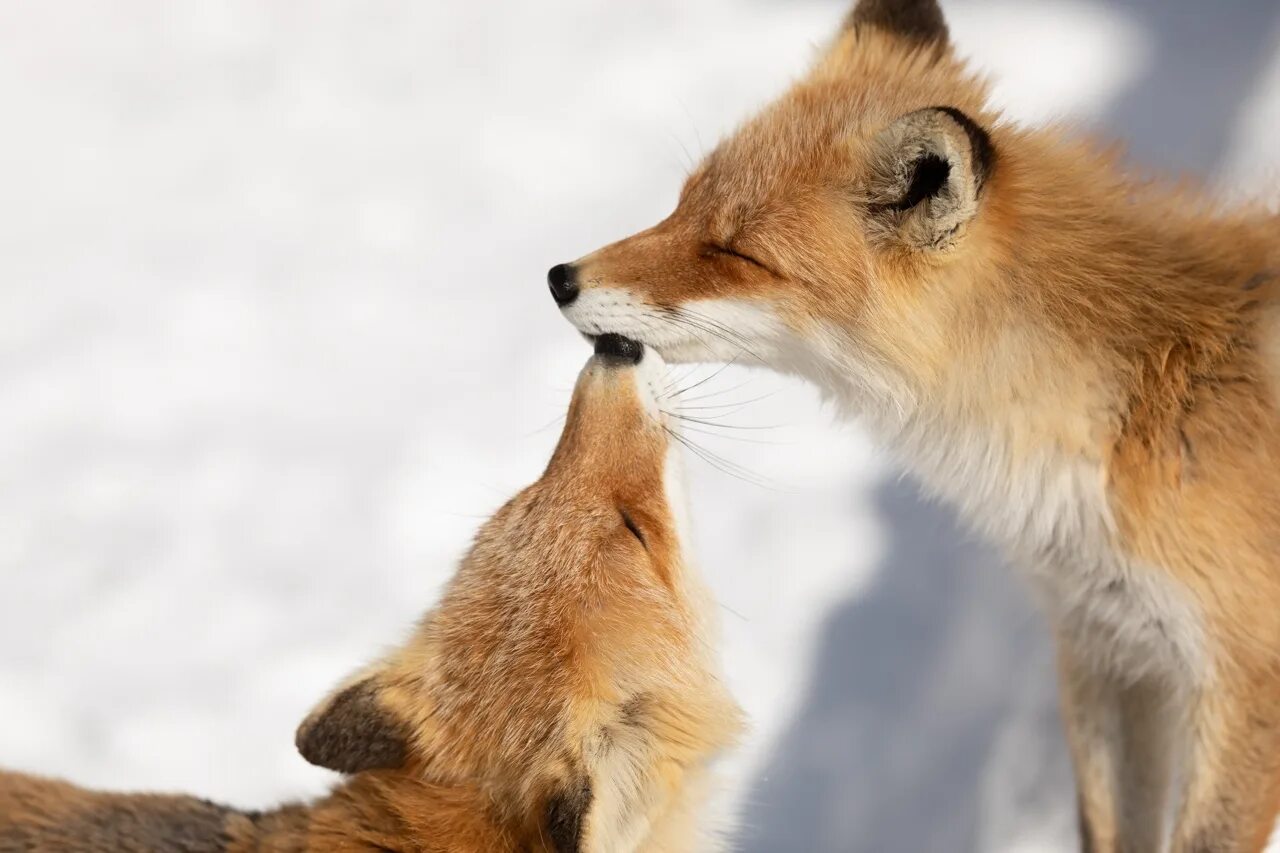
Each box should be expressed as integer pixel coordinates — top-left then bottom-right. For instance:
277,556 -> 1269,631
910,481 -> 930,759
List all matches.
778,136 -> 1275,564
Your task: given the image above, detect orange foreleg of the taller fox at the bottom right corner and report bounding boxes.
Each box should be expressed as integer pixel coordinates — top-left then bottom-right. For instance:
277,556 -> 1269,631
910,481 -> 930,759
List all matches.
1174,661 -> 1280,853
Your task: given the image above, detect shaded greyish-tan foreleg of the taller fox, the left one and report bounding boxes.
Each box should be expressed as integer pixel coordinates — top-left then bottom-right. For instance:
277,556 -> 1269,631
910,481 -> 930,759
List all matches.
1060,656 -> 1176,853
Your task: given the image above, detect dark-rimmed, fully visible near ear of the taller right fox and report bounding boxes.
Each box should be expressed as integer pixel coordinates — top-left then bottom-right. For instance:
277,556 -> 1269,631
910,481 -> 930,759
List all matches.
865,106 -> 996,250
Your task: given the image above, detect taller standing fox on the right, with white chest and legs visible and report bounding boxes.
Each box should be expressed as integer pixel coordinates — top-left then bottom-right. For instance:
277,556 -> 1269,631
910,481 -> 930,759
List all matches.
549,0 -> 1280,853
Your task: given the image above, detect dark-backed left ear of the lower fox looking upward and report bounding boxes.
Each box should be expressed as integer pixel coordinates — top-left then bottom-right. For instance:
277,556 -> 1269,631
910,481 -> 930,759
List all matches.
296,680 -> 408,774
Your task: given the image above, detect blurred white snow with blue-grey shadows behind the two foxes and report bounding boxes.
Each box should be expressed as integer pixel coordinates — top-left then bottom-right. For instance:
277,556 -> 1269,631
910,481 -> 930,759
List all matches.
0,0 -> 1280,853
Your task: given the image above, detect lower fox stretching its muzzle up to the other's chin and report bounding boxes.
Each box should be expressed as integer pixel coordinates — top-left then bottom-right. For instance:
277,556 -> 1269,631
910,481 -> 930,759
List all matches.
0,337 -> 740,853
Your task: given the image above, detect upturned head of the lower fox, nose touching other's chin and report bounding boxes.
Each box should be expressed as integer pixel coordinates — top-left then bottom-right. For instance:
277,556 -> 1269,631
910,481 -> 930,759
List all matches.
297,336 -> 740,853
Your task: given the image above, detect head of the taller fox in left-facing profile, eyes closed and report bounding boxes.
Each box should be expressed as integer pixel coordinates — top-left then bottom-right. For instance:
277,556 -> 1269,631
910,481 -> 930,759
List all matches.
548,0 -> 1000,417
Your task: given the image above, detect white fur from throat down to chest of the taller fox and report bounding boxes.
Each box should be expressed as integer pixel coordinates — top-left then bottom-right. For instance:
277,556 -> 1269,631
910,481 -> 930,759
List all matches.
757,312 -> 1208,681
